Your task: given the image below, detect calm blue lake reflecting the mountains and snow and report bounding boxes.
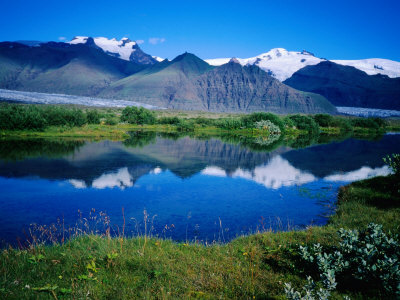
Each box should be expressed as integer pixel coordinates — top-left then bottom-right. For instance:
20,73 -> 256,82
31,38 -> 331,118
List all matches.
0,133 -> 400,243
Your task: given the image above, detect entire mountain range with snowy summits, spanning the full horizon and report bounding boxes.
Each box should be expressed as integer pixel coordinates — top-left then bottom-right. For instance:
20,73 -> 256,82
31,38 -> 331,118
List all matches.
0,36 -> 400,113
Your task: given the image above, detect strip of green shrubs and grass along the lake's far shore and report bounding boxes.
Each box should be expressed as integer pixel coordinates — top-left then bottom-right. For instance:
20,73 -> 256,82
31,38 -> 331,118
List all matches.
0,104 -> 400,137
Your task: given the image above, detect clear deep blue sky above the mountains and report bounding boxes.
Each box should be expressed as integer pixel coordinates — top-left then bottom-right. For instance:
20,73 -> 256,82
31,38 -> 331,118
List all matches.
0,0 -> 400,61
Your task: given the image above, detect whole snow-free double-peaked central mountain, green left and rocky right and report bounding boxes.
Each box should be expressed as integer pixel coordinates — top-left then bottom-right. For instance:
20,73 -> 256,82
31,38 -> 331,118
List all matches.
99,53 -> 336,113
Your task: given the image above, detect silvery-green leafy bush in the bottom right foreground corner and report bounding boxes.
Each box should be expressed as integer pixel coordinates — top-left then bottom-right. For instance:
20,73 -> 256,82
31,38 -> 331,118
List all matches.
285,223 -> 400,299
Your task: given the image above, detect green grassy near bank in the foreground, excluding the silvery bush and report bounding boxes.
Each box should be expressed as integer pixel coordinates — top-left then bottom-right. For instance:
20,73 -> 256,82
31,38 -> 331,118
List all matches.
0,176 -> 400,299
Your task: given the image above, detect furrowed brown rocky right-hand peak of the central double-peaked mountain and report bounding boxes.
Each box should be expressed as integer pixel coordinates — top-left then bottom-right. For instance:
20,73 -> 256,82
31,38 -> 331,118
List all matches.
195,60 -> 335,113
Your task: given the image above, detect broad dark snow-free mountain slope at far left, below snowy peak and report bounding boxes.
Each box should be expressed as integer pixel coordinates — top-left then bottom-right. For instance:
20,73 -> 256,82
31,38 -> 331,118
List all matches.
0,42 -> 144,96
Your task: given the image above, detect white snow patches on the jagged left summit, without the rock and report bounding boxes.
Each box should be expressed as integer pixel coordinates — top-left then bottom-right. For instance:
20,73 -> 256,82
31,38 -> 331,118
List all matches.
69,36 -> 136,60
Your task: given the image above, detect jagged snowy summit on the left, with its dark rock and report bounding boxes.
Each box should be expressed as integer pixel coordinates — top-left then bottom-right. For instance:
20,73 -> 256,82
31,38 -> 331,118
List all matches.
69,36 -> 158,65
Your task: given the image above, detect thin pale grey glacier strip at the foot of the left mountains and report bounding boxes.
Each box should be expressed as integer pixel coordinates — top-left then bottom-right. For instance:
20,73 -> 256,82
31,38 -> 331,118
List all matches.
0,89 -> 164,109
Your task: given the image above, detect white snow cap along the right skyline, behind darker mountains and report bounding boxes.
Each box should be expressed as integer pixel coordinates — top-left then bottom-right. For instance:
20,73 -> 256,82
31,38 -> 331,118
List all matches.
206,48 -> 400,81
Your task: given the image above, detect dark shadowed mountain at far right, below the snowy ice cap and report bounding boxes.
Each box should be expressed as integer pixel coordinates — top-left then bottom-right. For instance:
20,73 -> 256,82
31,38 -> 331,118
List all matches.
284,61 -> 400,110
